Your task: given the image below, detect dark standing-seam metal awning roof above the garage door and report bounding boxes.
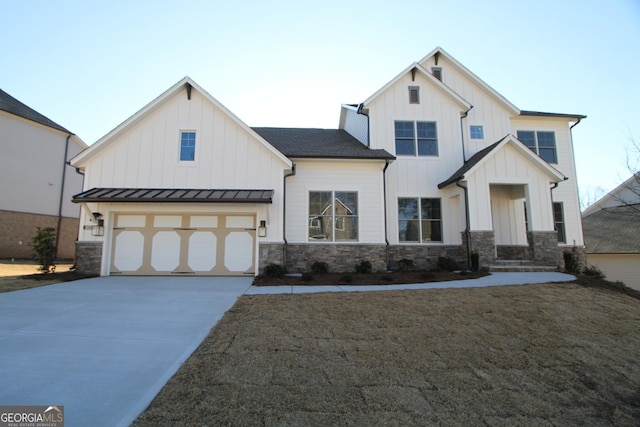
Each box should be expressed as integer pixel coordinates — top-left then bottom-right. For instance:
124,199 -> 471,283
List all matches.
73,188 -> 273,203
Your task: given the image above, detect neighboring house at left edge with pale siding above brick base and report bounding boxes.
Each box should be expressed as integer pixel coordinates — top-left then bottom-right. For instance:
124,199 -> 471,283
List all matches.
0,90 -> 87,259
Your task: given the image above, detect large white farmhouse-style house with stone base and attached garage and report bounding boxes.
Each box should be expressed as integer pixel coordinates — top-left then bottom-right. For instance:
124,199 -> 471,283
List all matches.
72,48 -> 585,275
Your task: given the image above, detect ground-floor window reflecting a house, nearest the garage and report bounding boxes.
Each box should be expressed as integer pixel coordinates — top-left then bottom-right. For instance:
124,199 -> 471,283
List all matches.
309,191 -> 358,241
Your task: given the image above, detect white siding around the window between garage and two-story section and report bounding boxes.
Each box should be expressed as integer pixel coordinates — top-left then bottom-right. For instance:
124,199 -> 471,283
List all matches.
286,159 -> 385,245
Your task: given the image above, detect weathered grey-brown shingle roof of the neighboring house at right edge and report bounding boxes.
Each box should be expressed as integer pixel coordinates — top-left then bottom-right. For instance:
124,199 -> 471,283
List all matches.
582,204 -> 640,254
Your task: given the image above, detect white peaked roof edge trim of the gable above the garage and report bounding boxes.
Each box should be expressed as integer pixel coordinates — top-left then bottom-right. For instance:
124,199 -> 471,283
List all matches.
71,77 -> 291,166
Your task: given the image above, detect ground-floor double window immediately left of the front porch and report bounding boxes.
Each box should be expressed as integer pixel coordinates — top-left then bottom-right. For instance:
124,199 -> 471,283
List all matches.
398,198 -> 442,243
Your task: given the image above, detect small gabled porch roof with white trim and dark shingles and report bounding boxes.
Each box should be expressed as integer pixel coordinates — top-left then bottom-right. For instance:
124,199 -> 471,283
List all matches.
438,134 -> 566,189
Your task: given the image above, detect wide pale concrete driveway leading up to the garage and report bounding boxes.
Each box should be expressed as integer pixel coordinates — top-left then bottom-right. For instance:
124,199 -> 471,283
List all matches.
0,277 -> 253,426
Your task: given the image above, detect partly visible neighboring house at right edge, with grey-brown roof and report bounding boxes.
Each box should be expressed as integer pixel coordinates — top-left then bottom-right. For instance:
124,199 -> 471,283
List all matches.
582,172 -> 640,290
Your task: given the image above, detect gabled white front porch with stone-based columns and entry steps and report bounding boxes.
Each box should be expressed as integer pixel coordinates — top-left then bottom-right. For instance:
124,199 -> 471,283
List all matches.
439,135 -> 565,268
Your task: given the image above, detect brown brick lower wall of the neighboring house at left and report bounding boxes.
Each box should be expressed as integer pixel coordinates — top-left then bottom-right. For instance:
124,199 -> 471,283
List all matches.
0,211 -> 79,259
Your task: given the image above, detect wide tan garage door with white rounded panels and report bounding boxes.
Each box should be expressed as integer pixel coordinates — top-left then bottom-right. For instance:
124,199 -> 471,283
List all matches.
111,214 -> 256,276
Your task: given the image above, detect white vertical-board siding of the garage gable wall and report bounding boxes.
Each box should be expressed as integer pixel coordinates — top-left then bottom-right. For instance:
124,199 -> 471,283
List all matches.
81,90 -> 289,241
